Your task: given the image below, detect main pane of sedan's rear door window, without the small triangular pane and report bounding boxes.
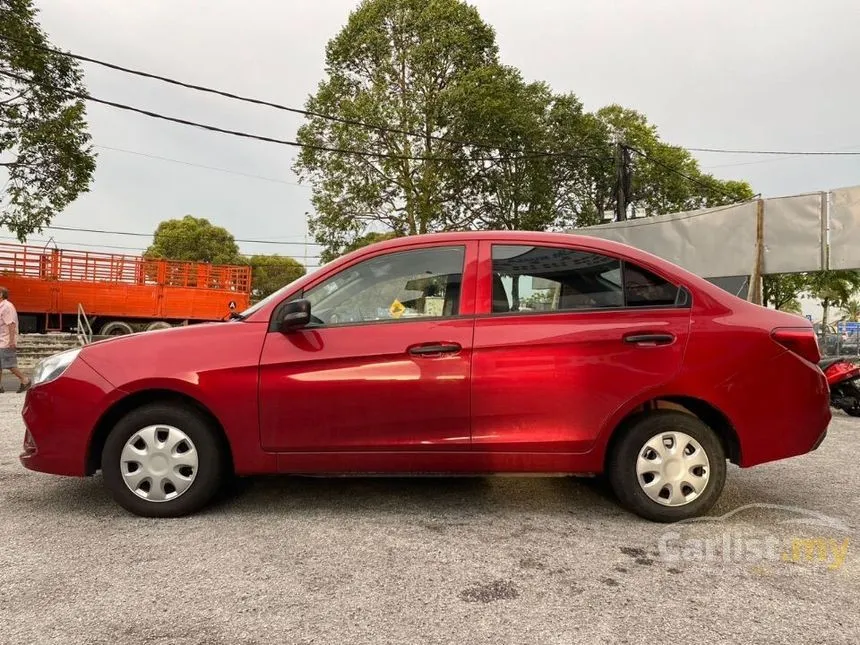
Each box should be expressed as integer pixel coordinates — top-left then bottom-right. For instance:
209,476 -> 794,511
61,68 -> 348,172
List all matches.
493,245 -> 624,313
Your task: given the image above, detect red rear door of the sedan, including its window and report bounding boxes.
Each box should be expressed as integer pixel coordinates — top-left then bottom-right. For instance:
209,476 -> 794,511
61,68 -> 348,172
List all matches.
472,242 -> 690,452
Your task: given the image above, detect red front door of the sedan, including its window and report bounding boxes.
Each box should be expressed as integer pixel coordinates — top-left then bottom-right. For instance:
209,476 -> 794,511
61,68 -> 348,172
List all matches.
260,243 -> 477,452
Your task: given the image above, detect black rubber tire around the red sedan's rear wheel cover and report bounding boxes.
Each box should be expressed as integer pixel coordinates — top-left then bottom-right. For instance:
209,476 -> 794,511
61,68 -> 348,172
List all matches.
607,410 -> 726,522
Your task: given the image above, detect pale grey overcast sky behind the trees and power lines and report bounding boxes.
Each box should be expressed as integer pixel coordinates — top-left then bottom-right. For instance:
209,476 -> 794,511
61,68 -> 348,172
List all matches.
16,0 -> 860,265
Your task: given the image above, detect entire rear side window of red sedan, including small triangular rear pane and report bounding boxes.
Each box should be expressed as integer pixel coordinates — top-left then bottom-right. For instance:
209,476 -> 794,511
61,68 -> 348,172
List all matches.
492,244 -> 686,313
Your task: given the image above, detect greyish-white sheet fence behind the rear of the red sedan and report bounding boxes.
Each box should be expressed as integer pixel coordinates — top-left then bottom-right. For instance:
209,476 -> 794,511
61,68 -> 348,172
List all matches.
575,186 -> 860,278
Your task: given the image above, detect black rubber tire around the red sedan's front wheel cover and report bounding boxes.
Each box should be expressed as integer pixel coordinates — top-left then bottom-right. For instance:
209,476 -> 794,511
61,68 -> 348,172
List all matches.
101,403 -> 229,517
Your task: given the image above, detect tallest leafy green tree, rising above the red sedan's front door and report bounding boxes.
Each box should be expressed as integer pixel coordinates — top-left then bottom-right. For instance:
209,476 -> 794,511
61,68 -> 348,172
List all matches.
294,0 -> 497,254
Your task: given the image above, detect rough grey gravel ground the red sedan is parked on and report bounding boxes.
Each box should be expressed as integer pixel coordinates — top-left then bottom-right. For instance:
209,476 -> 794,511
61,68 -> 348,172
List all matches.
0,394 -> 860,645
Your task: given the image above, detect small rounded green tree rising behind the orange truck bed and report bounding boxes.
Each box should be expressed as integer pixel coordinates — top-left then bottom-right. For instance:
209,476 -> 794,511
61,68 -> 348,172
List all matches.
144,215 -> 242,264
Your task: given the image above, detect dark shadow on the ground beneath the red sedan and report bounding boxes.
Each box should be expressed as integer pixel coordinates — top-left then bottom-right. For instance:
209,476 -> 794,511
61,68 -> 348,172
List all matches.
6,466 -> 828,522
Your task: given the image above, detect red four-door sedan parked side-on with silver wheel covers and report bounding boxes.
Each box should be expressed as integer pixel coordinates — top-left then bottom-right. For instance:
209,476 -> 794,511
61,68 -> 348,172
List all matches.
21,232 -> 830,521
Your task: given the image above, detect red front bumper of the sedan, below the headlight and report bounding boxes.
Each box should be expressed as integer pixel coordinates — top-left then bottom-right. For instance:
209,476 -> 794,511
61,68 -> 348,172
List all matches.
19,357 -> 119,477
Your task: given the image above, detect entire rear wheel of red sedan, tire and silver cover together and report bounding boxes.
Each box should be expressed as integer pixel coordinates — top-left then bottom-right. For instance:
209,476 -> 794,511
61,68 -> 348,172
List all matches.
607,411 -> 726,522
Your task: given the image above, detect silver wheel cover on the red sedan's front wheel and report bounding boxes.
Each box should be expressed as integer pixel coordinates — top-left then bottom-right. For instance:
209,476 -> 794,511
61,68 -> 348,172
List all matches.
119,424 -> 198,502
